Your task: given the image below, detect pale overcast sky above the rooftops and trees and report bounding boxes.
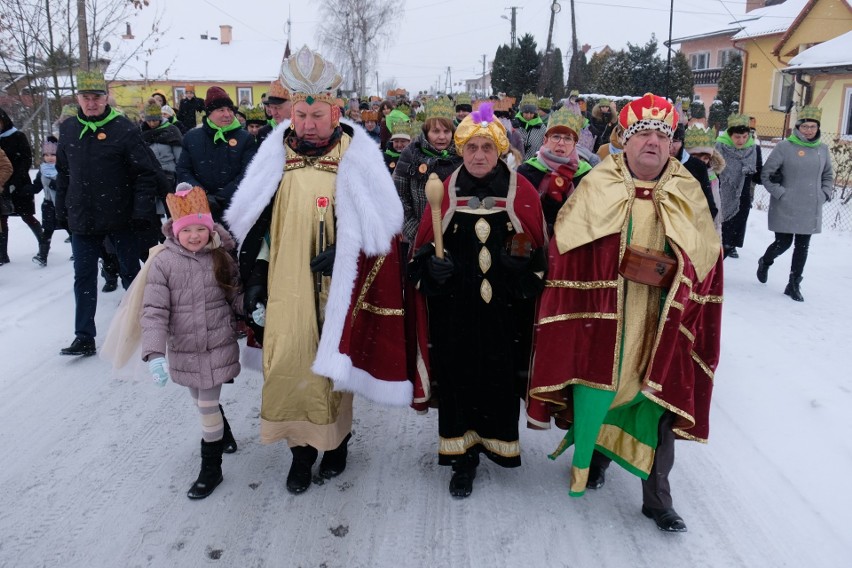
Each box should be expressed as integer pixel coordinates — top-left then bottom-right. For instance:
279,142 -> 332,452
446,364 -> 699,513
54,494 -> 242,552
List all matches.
125,0 -> 745,92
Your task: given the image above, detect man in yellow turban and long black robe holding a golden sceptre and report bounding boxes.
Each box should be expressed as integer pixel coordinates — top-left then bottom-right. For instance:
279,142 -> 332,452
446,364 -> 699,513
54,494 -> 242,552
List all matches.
409,103 -> 547,498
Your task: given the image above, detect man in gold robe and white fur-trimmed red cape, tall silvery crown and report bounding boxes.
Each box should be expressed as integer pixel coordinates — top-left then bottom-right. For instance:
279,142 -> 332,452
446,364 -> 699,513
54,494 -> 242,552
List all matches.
225,47 -> 412,494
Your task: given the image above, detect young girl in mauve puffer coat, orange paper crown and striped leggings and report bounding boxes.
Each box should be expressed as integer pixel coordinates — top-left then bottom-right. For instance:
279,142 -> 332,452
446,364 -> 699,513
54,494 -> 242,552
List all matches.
140,184 -> 243,499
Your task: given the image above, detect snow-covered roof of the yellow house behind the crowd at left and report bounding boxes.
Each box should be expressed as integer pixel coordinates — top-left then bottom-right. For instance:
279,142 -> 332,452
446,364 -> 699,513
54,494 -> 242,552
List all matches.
105,38 -> 285,83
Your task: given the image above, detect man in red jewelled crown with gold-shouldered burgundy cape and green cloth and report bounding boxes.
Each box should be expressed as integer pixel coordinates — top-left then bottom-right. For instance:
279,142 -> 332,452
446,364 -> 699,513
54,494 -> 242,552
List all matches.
527,94 -> 722,532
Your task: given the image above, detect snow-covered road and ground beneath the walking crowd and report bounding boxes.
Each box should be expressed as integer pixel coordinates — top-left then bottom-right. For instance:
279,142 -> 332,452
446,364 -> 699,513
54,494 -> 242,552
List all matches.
0,202 -> 852,568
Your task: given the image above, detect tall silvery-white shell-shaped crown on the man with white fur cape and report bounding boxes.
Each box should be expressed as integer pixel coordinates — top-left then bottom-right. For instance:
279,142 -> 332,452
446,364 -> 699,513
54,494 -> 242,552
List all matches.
279,45 -> 343,105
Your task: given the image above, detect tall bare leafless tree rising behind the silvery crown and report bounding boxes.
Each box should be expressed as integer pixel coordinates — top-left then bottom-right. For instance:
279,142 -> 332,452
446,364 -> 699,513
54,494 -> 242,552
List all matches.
317,0 -> 405,94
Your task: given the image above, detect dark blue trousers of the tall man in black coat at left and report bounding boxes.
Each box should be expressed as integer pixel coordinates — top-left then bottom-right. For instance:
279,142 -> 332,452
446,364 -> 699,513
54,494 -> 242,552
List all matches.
71,231 -> 139,339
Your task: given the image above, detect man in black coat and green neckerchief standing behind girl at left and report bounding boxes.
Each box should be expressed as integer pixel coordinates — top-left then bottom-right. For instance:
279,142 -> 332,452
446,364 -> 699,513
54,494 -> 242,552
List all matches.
56,71 -> 159,355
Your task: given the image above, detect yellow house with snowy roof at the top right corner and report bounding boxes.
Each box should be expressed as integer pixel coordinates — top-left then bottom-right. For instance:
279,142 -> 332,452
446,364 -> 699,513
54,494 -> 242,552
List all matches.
733,0 -> 852,137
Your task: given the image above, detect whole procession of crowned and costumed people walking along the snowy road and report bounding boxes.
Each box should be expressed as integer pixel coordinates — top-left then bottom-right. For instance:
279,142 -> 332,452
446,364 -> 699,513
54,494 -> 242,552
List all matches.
0,41 -> 833,532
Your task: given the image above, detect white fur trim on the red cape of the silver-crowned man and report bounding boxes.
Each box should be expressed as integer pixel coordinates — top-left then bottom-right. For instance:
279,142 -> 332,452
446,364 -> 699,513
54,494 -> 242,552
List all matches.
220,120 -> 412,406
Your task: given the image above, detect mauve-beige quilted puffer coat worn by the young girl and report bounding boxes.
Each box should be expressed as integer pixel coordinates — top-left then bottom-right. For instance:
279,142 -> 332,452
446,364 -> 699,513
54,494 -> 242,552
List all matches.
141,221 -> 243,389
